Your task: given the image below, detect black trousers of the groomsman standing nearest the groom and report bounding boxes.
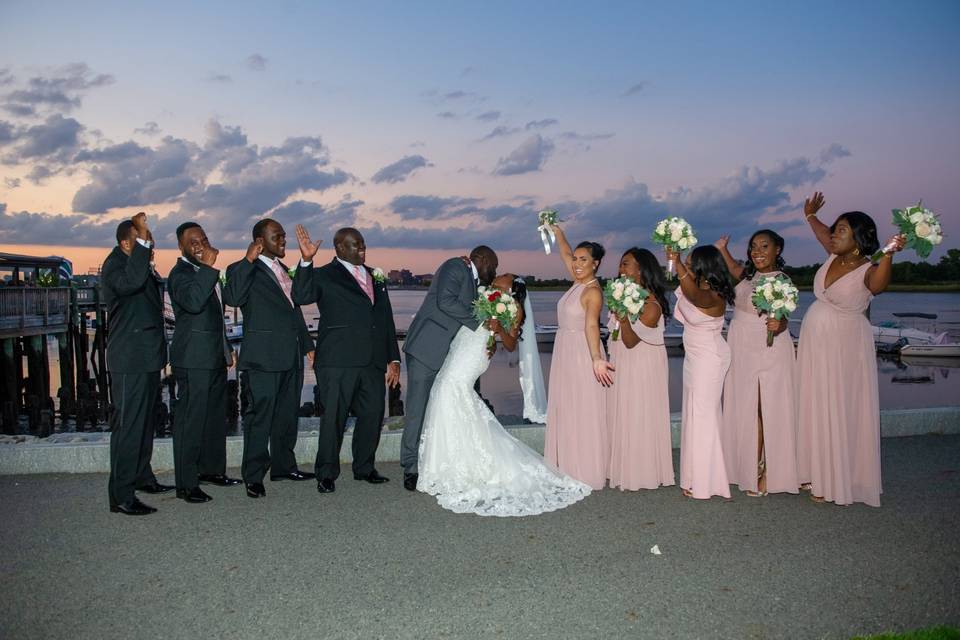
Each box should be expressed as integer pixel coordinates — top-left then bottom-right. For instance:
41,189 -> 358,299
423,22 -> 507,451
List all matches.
315,367 -> 386,479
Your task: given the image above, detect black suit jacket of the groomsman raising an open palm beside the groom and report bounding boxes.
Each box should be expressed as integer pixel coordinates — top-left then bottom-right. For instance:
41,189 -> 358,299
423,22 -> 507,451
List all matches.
293,258 -> 400,371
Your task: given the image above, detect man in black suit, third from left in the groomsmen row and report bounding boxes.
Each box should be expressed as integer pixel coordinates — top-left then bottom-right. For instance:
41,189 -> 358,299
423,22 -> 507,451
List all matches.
223,218 -> 314,498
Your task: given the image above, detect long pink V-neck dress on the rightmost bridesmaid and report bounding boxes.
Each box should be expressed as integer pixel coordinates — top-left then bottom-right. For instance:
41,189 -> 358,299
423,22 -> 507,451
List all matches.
797,255 -> 882,507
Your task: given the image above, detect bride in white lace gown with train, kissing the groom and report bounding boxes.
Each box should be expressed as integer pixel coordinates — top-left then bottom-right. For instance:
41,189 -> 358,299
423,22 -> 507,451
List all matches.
417,274 -> 590,516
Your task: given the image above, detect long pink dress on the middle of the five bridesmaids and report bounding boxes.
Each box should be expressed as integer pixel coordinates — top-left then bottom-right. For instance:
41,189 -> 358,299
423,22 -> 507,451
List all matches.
673,287 -> 730,499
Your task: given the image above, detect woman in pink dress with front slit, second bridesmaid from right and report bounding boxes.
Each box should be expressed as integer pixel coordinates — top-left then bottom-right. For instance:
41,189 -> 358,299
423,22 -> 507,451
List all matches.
716,229 -> 800,497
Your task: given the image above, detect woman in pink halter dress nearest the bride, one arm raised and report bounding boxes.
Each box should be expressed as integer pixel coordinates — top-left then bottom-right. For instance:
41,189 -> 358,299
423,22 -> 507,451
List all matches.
543,226 -> 613,489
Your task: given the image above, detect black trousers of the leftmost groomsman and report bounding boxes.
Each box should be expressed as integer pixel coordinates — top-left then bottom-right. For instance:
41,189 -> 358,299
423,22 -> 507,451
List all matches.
107,371 -> 160,505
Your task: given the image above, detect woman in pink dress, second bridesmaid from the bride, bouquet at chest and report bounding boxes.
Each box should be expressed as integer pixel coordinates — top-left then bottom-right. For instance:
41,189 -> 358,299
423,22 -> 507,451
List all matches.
607,247 -> 674,491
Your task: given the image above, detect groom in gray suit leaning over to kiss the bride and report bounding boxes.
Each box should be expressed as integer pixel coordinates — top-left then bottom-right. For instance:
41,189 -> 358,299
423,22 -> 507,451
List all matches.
400,245 -> 498,491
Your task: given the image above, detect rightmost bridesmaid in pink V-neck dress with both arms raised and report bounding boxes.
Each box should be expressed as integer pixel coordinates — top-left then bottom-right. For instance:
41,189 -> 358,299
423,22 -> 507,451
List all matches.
797,192 -> 904,507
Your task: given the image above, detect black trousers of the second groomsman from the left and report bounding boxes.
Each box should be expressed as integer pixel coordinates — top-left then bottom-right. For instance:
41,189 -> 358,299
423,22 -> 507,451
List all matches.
173,366 -> 227,489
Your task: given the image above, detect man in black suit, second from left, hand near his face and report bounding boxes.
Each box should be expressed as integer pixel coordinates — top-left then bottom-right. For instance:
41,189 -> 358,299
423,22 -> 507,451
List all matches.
167,222 -> 240,503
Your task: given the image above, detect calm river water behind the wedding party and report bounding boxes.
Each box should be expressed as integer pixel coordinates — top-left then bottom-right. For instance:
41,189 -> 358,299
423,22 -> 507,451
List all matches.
41,291 -> 960,416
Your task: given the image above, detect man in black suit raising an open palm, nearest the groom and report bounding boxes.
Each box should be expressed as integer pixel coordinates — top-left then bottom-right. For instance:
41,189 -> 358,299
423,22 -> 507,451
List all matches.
293,225 -> 400,493
